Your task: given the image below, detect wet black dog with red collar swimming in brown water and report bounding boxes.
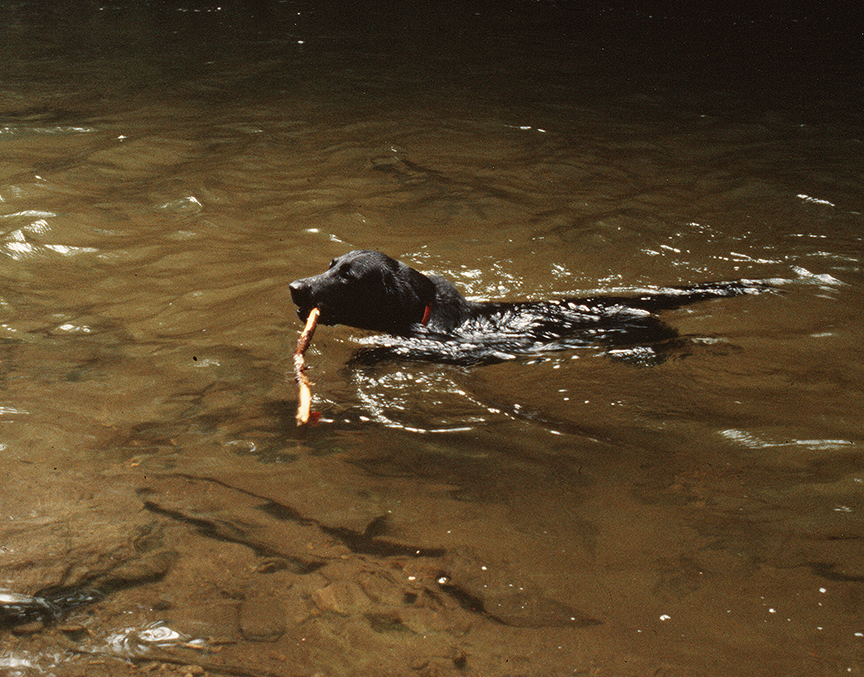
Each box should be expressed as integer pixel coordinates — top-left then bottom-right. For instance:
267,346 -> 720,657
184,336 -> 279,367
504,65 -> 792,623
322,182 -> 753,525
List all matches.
290,250 -> 771,362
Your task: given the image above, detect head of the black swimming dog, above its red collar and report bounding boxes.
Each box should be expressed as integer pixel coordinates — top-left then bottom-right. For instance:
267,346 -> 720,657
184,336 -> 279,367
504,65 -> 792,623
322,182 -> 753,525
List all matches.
290,250 -> 435,336
